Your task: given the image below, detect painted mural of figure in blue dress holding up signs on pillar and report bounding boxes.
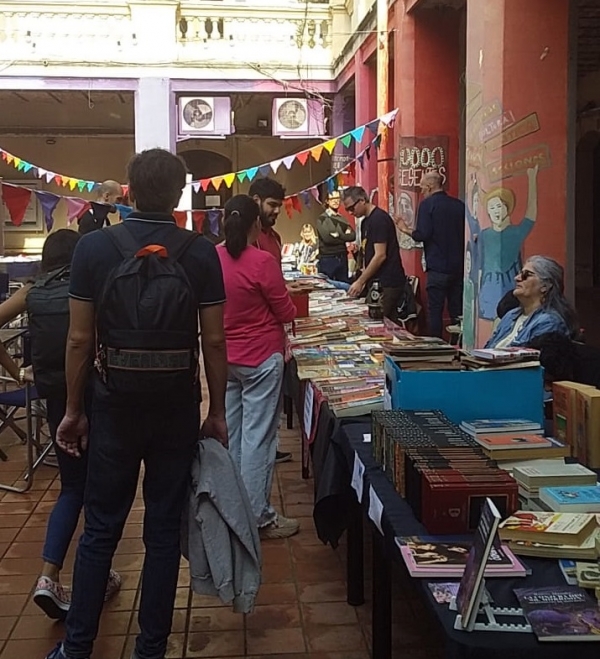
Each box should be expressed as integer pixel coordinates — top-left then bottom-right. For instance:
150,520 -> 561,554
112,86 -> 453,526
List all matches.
463,84 -> 551,349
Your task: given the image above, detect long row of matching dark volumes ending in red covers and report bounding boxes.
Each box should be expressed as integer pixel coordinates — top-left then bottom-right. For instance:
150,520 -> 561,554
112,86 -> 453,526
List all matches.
371,410 -> 518,535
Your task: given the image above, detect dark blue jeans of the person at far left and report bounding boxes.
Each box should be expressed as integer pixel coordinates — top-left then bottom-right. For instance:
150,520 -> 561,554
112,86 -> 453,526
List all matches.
42,395 -> 88,569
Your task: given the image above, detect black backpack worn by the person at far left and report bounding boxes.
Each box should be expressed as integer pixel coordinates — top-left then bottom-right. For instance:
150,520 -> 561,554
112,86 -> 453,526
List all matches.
27,266 -> 70,398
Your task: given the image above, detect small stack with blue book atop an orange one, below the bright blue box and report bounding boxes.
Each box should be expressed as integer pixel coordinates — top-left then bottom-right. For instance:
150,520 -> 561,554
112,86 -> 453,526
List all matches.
460,419 -> 569,462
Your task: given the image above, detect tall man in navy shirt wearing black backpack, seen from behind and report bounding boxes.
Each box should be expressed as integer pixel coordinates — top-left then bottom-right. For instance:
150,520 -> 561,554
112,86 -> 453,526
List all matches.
48,149 -> 227,659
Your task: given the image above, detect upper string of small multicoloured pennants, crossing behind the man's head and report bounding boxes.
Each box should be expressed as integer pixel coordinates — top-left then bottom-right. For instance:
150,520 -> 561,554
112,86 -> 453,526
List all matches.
0,109 -> 398,192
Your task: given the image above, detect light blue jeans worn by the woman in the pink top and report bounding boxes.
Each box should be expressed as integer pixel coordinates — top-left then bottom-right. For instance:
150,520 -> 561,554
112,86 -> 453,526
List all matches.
225,353 -> 283,527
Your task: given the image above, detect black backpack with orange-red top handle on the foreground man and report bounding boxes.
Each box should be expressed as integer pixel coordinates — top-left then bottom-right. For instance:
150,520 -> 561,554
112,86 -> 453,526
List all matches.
96,223 -> 199,403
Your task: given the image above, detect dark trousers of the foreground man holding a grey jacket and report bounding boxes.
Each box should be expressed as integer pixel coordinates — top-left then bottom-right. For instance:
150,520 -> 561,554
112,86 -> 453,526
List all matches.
64,403 -> 200,659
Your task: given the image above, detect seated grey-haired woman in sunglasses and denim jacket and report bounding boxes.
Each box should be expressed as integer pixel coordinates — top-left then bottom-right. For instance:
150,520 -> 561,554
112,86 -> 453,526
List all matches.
485,256 -> 579,348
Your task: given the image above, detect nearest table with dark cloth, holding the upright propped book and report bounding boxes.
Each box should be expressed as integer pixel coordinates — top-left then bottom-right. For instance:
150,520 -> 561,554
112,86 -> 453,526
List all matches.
331,423 -> 598,659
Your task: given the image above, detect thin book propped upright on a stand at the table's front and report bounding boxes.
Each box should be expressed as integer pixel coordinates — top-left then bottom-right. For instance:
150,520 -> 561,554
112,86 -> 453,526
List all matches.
456,499 -> 500,631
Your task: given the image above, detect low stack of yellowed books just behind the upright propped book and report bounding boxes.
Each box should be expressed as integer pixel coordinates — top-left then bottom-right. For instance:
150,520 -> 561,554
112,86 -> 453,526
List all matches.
500,510 -> 599,560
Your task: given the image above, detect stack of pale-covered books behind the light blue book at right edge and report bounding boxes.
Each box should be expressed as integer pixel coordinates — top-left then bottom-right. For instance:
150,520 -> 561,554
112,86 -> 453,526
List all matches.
512,460 -> 600,512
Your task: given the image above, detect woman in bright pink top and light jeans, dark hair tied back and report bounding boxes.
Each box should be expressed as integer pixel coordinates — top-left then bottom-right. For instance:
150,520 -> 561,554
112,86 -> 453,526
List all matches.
217,195 -> 299,538
